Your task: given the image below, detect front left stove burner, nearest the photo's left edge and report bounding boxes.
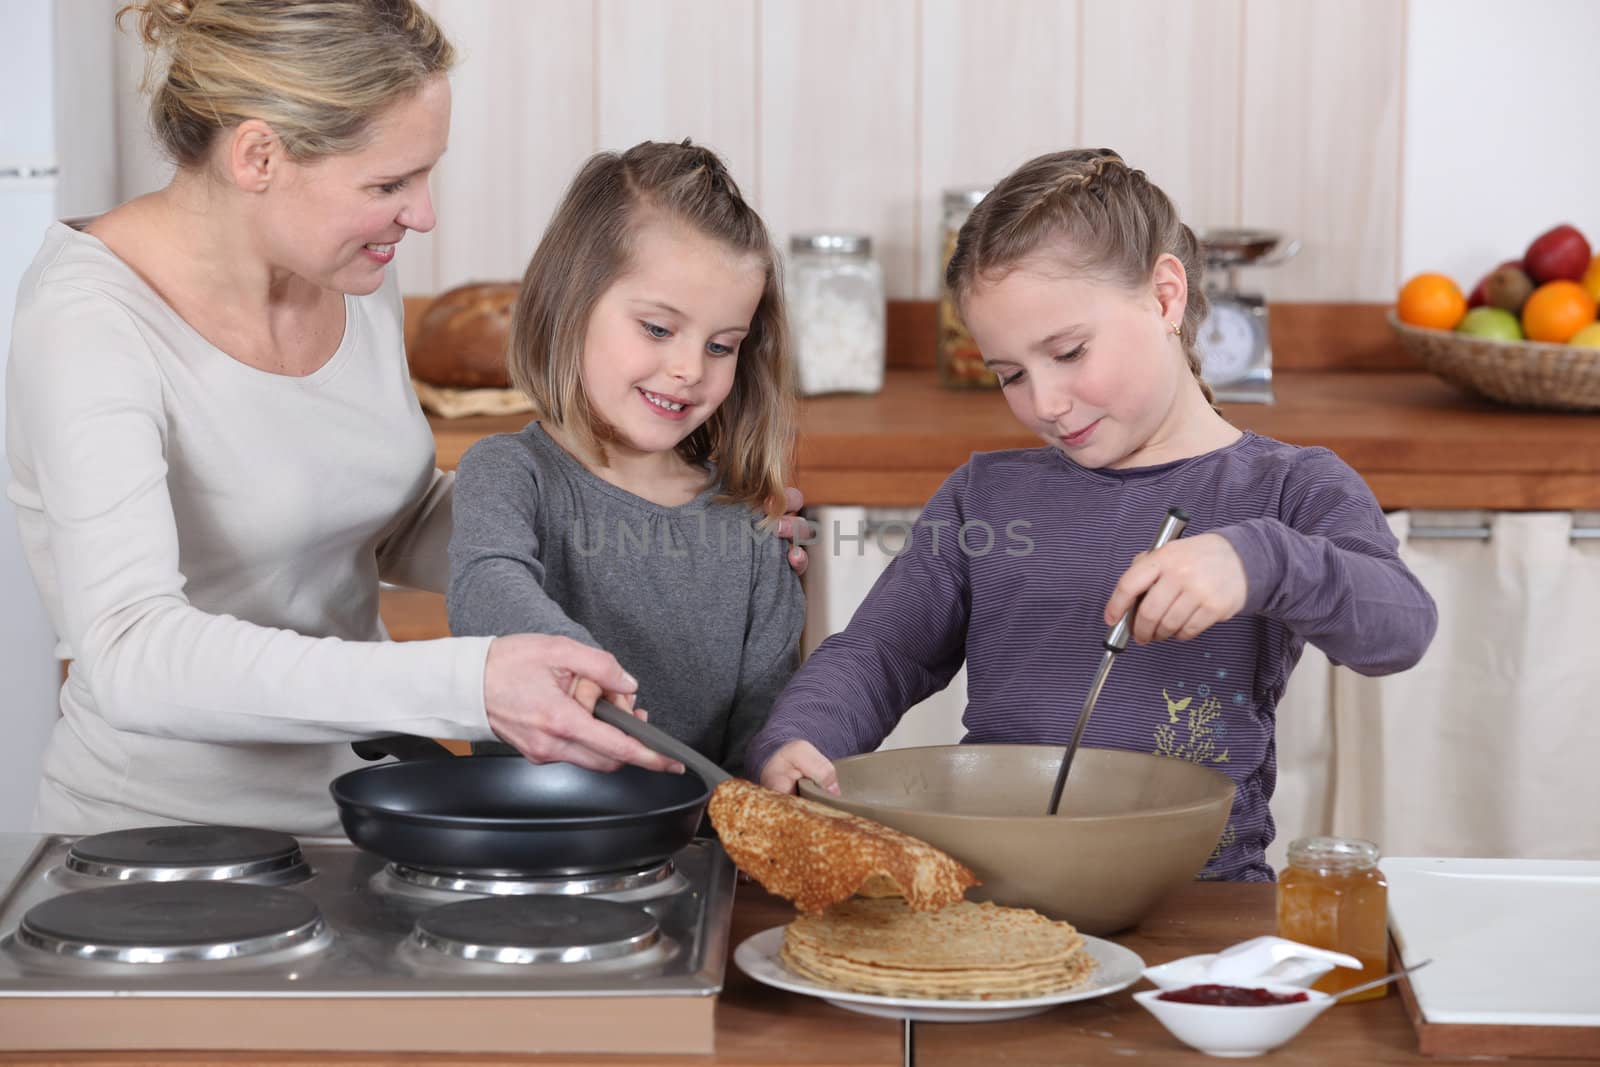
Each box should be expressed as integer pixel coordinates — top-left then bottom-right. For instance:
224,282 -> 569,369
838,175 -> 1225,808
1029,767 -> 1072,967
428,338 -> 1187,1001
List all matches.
16,881 -> 326,963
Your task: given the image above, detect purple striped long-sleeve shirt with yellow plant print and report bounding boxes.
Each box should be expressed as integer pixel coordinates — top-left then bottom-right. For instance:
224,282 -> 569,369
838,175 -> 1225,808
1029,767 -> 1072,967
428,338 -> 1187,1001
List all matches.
747,432 -> 1437,881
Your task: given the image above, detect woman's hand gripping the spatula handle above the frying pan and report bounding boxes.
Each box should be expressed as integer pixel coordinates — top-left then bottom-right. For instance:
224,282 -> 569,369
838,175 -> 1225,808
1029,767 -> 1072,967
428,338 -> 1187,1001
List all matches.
483,633 -> 683,774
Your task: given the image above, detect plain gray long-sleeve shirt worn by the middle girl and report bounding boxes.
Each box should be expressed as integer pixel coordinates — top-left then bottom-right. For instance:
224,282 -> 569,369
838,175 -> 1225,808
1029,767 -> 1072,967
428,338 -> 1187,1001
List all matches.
448,422 -> 805,773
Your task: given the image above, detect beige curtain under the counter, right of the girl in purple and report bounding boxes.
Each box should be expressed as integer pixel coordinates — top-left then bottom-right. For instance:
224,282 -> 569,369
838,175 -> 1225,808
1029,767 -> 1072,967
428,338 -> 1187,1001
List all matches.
1331,512 -> 1600,859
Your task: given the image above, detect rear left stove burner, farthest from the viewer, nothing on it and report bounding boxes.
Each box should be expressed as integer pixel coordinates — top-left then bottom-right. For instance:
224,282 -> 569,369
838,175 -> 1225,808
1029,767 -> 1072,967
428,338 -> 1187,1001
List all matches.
62,825 -> 306,881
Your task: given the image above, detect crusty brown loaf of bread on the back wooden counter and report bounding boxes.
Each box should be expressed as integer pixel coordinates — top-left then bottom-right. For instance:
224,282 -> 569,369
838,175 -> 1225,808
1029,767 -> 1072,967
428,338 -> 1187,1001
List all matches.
406,282 -> 518,389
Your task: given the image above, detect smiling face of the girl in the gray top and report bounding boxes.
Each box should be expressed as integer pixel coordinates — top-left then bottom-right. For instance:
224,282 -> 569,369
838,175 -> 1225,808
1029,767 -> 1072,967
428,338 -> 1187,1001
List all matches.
582,218 -> 766,454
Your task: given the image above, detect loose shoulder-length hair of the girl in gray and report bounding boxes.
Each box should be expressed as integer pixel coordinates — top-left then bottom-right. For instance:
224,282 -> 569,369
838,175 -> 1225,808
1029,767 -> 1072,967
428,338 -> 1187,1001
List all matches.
507,141 -> 795,517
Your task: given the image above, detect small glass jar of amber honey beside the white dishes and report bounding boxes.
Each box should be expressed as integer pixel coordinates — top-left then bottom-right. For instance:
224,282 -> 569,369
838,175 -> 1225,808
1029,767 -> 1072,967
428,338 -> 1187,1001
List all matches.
1278,837 -> 1389,1003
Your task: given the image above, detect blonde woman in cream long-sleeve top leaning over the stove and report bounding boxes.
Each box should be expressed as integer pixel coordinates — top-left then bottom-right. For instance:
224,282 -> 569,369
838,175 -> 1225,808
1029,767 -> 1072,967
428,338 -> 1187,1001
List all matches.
6,0 -> 800,835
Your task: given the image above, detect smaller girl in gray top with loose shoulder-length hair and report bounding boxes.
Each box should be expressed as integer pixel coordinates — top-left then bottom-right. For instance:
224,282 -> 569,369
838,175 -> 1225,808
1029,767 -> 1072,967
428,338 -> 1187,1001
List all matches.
448,141 -> 805,771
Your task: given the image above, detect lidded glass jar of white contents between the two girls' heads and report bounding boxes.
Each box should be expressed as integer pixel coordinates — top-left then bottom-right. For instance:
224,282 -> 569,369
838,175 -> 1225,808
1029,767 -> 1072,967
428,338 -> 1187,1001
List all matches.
784,234 -> 885,397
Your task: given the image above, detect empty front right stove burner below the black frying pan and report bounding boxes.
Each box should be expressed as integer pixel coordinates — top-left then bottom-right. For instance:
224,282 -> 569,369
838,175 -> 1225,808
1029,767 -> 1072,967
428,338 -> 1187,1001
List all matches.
411,896 -> 661,963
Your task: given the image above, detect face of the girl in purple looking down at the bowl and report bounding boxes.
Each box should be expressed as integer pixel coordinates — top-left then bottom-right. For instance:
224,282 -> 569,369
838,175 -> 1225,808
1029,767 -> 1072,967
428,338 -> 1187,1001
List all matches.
962,256 -> 1197,469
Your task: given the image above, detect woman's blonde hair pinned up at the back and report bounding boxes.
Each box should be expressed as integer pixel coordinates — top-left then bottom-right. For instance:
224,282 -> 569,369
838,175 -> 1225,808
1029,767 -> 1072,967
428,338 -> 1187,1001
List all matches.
117,0 -> 454,166
